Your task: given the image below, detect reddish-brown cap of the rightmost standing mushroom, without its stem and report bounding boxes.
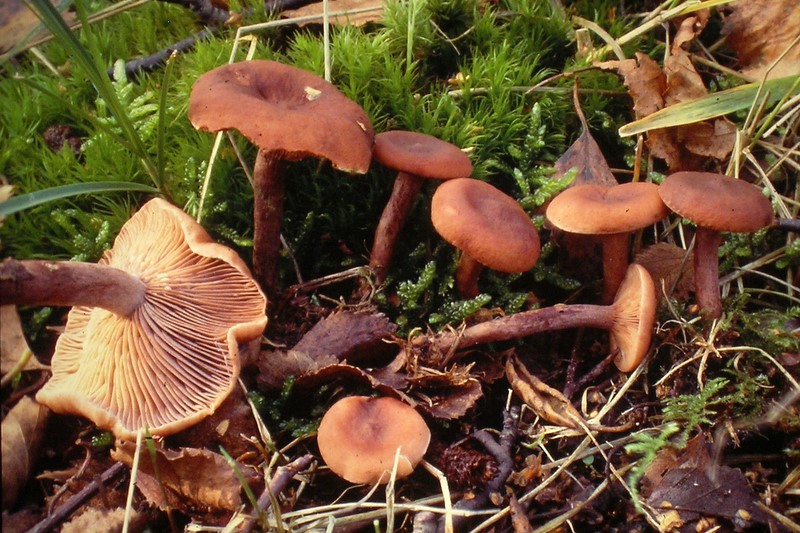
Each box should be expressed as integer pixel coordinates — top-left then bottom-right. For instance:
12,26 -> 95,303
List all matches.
659,171 -> 773,233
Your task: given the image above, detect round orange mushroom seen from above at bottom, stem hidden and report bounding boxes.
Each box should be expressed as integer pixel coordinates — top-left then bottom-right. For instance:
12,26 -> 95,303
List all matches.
317,396 -> 431,485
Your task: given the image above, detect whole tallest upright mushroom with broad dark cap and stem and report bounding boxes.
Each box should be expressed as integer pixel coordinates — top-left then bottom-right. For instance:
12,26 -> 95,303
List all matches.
189,60 -> 374,297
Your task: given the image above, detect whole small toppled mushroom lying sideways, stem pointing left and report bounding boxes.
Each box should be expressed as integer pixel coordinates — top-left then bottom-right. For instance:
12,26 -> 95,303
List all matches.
413,263 -> 657,372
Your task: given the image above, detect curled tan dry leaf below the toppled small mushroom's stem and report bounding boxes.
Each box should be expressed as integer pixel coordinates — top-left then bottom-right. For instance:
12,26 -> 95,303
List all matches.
506,357 -> 586,429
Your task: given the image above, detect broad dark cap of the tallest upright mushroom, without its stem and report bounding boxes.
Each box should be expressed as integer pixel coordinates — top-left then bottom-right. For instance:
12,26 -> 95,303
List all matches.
189,60 -> 374,174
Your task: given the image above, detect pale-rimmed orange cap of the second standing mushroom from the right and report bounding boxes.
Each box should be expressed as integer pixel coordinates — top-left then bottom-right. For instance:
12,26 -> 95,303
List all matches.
545,182 -> 669,235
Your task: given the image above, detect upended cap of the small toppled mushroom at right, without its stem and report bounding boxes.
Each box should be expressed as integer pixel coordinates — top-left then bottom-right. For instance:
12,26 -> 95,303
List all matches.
610,263 -> 657,372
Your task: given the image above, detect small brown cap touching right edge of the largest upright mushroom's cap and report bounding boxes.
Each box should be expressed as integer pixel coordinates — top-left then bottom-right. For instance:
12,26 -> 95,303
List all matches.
373,130 -> 472,180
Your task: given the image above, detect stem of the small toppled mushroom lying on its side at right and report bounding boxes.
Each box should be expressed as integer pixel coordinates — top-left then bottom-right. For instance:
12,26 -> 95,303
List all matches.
415,304 -> 617,352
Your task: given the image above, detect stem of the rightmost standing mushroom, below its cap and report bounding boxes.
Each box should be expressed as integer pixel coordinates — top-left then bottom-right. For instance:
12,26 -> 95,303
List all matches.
694,226 -> 722,318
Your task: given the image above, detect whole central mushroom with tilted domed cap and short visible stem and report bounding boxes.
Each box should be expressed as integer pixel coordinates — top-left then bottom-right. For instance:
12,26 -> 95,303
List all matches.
431,178 -> 540,298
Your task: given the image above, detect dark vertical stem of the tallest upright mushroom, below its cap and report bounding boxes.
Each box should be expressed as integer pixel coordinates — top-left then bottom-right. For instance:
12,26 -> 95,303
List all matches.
253,150 -> 286,302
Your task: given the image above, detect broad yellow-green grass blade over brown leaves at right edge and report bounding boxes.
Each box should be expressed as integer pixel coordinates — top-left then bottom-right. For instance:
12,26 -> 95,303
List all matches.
619,76 -> 800,137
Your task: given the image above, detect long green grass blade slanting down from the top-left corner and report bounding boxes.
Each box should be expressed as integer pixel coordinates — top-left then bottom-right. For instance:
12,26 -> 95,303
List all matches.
27,0 -> 162,189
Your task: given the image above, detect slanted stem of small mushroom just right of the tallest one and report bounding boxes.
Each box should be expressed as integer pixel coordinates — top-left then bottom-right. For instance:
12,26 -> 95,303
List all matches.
369,172 -> 423,285
